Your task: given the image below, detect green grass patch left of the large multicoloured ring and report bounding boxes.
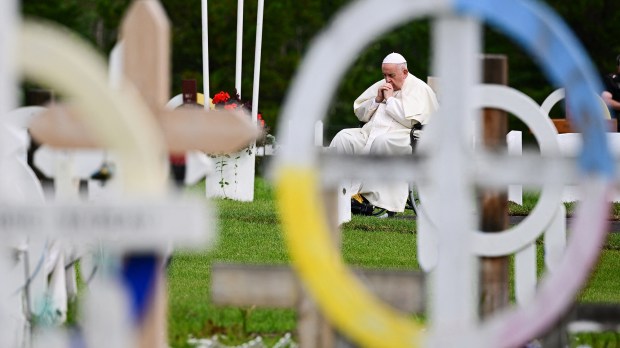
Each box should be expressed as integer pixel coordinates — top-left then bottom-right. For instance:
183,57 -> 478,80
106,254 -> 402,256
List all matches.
168,180 -> 295,347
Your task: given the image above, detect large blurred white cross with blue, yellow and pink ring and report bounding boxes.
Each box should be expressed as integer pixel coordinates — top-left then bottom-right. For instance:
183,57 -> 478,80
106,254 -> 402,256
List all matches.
274,0 -> 614,347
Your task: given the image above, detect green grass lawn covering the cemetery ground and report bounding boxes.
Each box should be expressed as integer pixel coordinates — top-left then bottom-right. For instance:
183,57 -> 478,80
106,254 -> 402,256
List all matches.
168,178 -> 620,347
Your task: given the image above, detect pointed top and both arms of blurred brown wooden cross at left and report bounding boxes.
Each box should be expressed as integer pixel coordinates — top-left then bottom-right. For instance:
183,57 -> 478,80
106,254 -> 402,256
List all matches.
31,0 -> 258,153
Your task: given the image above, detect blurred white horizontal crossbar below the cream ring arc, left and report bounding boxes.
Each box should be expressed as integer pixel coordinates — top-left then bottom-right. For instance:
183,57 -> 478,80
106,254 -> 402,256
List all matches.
0,199 -> 213,250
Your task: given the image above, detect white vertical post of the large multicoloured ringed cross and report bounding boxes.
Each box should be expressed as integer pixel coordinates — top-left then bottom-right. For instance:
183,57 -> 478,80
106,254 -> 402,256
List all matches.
426,16 -> 480,340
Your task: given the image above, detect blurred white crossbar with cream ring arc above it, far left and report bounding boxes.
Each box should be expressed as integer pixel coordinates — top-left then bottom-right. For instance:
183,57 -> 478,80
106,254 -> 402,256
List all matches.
0,4 -> 236,345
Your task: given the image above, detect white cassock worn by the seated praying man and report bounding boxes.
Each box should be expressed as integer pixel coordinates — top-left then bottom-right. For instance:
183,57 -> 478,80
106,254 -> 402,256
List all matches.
329,74 -> 439,212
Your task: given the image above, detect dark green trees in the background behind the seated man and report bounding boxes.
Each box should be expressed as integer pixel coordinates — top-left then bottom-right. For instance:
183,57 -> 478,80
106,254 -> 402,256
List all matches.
21,0 -> 620,140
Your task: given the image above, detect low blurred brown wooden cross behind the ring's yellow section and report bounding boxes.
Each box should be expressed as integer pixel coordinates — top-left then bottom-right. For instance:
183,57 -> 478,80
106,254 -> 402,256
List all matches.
211,189 -> 426,348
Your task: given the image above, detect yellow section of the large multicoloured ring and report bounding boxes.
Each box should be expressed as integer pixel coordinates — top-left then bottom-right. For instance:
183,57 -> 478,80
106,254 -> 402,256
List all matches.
276,166 -> 423,347
